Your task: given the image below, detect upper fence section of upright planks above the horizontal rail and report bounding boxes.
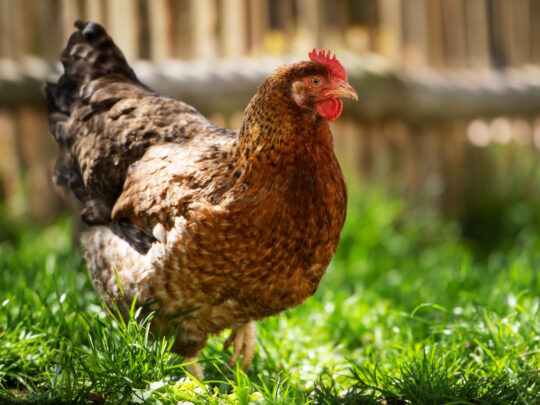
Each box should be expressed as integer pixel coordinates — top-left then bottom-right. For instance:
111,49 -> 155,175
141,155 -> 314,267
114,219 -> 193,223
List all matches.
0,0 -> 540,68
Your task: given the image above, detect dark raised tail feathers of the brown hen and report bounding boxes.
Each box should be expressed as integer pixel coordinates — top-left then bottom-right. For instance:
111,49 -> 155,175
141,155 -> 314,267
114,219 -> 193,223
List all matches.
45,21 -> 142,224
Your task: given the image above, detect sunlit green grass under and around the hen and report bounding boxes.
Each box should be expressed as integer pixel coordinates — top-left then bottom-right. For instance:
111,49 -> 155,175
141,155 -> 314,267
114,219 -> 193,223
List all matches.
0,185 -> 540,404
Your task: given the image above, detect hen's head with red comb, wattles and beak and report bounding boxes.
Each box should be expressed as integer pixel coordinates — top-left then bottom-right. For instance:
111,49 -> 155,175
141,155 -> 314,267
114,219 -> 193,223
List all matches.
291,49 -> 358,121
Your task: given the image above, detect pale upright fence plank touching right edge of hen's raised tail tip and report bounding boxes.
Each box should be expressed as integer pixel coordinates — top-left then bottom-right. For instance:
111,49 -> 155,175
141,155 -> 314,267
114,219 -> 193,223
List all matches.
107,0 -> 139,61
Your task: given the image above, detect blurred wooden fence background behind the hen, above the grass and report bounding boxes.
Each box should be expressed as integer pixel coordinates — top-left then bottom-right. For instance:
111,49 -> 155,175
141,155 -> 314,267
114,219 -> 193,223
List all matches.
0,0 -> 540,251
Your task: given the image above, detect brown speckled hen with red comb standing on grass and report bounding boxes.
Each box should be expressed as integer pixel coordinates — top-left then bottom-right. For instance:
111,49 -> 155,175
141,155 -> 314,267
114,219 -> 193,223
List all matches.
46,22 -> 358,377
